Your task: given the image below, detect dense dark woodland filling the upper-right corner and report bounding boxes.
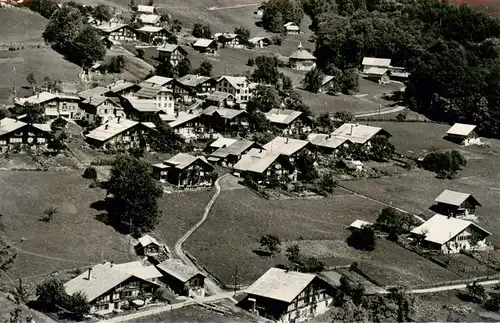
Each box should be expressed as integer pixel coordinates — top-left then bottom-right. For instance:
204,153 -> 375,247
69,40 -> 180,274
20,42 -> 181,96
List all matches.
264,0 -> 500,137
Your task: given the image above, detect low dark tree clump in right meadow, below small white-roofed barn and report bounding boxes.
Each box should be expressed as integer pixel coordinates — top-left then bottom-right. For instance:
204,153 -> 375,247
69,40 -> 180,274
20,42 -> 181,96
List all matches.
422,150 -> 467,179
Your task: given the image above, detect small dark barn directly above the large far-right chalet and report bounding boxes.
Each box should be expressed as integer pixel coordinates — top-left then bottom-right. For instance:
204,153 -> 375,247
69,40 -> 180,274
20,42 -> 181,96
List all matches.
434,190 -> 481,217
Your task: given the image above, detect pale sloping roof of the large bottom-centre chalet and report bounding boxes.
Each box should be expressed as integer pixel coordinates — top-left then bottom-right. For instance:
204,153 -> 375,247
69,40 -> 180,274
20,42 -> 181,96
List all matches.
246,268 -> 317,303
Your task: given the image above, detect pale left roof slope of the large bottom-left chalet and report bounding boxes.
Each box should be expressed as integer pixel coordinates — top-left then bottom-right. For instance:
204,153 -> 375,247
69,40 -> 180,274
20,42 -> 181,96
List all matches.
64,264 -> 133,302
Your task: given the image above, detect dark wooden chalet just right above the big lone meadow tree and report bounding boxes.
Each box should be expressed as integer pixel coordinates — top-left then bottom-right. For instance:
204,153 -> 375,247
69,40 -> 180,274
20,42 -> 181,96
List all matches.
153,153 -> 214,187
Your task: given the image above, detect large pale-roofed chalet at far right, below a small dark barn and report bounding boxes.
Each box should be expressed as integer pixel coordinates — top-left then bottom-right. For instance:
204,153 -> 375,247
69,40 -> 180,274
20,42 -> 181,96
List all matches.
411,214 -> 491,254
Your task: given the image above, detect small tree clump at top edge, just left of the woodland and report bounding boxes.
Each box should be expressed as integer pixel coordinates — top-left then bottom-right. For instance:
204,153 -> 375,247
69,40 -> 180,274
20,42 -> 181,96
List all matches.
262,0 -> 304,33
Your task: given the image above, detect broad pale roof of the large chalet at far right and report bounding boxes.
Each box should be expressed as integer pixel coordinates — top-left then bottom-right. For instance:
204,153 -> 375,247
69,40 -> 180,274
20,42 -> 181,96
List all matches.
411,214 -> 491,245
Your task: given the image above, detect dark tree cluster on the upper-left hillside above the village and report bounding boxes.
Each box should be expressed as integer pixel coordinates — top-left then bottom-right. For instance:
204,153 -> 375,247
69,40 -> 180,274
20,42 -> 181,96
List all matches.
43,2 -> 106,67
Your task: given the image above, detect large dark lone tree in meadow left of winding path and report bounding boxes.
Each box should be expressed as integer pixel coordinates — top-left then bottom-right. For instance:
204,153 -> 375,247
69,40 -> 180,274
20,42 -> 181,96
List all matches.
108,156 -> 163,233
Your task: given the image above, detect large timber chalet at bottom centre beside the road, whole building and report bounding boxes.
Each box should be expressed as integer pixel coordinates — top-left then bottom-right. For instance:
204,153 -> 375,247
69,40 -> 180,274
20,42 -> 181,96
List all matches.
239,268 -> 336,323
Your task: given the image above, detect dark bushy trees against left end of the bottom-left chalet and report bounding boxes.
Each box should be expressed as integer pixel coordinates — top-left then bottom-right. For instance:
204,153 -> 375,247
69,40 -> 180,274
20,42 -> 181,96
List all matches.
36,278 -> 90,315
